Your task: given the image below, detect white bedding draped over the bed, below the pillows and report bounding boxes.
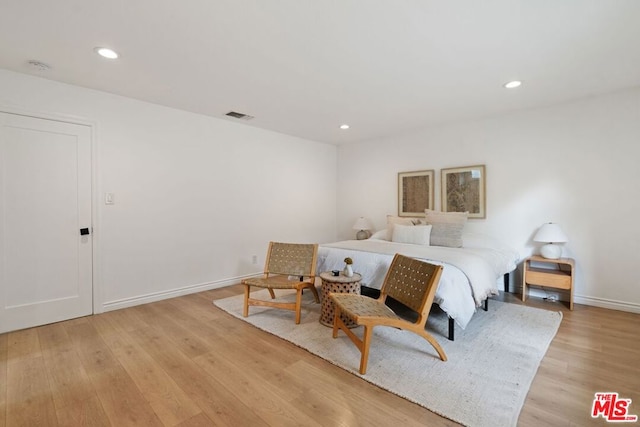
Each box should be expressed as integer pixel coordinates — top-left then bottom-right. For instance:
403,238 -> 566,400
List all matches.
317,236 -> 519,329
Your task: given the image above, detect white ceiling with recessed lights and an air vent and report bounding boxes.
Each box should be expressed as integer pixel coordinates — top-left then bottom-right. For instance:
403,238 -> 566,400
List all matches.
0,0 -> 640,144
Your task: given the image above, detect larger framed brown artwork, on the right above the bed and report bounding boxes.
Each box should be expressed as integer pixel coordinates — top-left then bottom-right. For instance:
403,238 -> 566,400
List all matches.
440,165 -> 487,218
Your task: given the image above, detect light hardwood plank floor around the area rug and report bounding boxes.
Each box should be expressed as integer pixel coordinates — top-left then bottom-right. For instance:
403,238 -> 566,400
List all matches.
0,286 -> 640,427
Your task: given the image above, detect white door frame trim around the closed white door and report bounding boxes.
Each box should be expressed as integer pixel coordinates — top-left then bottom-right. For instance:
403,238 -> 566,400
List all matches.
0,103 -> 103,314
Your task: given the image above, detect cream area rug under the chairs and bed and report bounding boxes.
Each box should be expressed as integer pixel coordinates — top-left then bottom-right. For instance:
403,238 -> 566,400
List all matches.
213,290 -> 562,427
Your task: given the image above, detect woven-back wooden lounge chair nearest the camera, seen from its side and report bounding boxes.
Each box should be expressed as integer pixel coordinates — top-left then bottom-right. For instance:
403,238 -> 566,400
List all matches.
329,254 -> 447,375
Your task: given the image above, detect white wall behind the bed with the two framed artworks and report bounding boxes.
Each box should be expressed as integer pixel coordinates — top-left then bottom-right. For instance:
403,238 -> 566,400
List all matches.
338,89 -> 640,312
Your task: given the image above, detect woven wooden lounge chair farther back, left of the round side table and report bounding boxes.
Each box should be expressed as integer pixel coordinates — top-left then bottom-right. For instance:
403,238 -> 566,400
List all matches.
242,242 -> 320,325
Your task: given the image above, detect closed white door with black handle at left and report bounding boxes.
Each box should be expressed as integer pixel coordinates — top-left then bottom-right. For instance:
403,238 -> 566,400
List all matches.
0,112 -> 93,333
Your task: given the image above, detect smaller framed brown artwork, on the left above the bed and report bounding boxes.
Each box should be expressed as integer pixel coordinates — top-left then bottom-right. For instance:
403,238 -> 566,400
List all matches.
398,170 -> 434,216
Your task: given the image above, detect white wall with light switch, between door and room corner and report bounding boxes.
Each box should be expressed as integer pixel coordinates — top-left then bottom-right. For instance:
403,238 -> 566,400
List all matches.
0,70 -> 337,312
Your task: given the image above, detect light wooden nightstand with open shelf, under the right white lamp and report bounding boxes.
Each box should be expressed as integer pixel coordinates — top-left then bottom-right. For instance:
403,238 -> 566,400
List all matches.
522,255 -> 576,310
